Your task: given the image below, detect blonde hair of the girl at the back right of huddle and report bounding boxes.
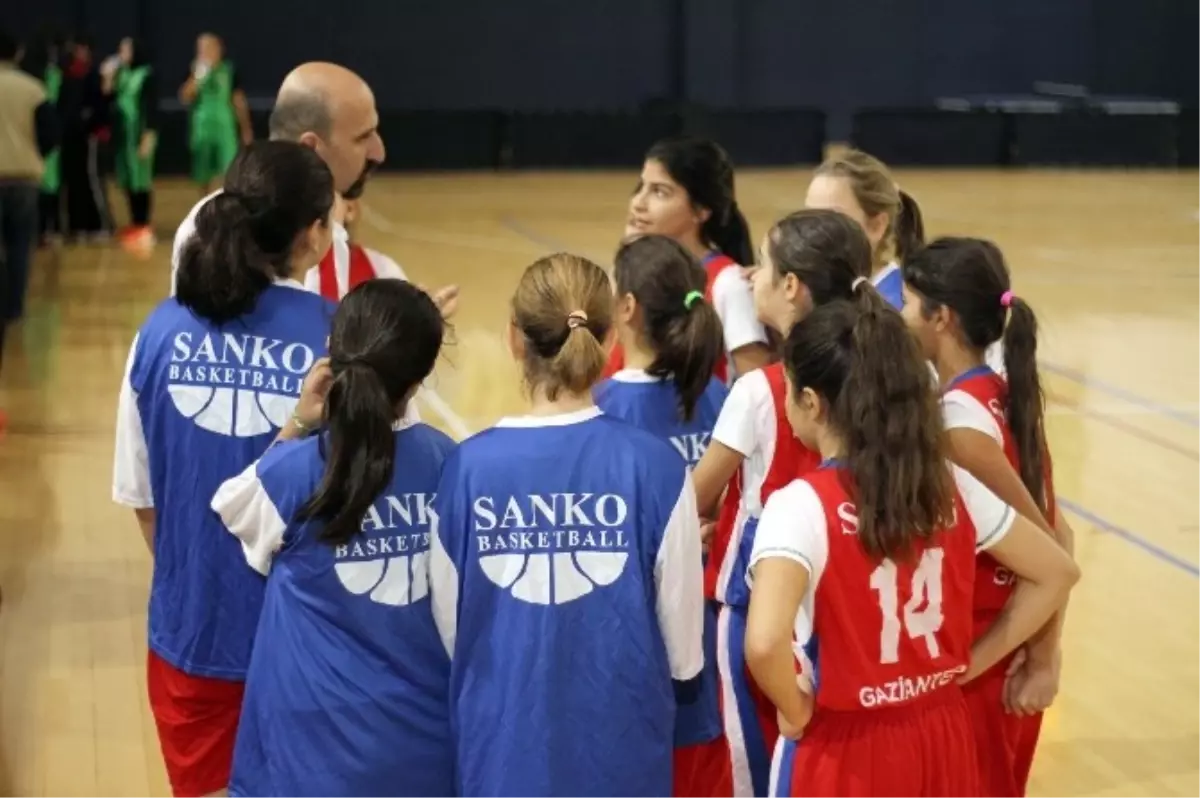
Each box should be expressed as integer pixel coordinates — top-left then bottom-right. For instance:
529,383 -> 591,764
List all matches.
816,150 -> 925,266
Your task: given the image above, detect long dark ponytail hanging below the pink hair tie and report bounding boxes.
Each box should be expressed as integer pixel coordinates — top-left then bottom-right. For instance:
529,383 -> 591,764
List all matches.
1002,296 -> 1051,518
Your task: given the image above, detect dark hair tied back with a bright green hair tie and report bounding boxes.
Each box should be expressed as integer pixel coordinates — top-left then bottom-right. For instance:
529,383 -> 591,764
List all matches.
614,235 -> 725,421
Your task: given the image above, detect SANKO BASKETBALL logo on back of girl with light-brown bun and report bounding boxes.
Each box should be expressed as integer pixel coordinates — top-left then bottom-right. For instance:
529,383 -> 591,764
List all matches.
473,493 -> 629,605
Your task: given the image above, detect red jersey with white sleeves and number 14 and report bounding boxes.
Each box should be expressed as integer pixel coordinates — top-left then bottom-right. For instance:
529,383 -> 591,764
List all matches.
750,463 -> 1015,712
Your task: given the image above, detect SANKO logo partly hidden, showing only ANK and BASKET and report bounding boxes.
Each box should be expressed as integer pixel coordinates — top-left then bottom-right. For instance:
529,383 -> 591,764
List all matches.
334,493 -> 434,607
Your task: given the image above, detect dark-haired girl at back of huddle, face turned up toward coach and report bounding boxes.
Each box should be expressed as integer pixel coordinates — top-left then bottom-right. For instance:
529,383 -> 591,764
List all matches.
605,137 -> 770,383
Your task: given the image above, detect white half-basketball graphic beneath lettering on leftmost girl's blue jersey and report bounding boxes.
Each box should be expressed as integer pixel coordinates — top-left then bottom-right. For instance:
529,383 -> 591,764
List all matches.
167,385 -> 298,438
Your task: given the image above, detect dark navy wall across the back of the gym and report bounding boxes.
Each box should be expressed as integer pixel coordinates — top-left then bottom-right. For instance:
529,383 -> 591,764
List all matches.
0,0 -> 1200,126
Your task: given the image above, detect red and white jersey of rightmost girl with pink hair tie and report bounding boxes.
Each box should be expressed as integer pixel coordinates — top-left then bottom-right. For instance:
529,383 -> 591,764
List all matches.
942,366 -> 1054,629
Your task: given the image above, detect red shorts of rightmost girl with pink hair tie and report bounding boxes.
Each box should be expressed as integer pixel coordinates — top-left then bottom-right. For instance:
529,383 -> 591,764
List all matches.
962,659 -> 1042,798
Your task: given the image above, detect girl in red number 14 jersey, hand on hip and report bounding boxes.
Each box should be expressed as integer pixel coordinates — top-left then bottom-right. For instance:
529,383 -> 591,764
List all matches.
745,292 -> 1079,798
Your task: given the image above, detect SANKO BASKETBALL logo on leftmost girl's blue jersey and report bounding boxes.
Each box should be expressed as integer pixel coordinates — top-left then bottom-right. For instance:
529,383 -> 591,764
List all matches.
167,331 -> 317,438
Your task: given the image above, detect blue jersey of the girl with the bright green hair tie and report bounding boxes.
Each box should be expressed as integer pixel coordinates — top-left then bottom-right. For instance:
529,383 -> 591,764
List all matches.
593,368 -> 728,748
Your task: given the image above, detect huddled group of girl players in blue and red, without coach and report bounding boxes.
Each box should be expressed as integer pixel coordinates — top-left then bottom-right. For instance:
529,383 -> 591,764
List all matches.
114,65 -> 1079,798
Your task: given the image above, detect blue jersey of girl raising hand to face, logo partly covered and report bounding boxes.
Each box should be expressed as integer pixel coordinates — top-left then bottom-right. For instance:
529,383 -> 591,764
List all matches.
212,424 -> 455,798
